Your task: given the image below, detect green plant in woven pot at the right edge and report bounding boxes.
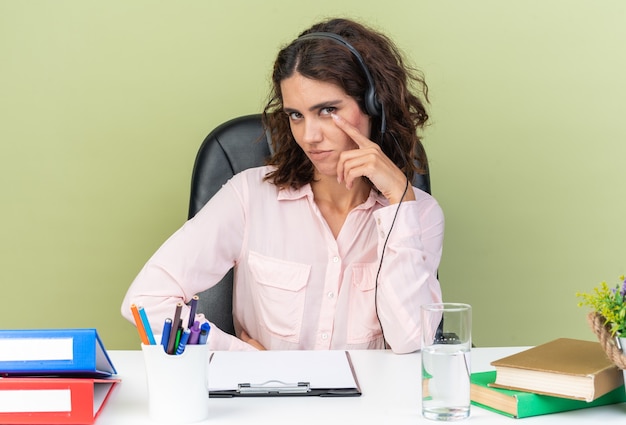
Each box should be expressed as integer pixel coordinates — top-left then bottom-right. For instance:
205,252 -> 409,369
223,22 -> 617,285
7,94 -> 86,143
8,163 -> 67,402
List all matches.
576,276 -> 626,372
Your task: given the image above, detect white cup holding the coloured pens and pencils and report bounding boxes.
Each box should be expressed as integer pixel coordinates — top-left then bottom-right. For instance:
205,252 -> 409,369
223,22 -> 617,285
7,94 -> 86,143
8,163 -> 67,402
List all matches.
141,344 -> 209,424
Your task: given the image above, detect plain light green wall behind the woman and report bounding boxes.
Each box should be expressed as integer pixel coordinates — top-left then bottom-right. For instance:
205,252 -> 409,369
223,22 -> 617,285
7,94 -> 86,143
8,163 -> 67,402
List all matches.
0,0 -> 626,349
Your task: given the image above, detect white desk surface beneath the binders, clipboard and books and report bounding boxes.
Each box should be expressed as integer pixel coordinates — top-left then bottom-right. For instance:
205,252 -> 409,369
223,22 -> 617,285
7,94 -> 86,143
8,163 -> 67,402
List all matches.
96,347 -> 626,425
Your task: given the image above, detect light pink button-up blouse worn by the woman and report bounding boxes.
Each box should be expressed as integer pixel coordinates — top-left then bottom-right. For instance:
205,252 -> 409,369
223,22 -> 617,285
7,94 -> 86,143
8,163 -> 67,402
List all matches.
122,167 -> 444,353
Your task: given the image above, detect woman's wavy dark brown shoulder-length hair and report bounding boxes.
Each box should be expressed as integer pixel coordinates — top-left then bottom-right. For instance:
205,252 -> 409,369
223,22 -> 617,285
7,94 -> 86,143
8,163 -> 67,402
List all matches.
262,19 -> 428,189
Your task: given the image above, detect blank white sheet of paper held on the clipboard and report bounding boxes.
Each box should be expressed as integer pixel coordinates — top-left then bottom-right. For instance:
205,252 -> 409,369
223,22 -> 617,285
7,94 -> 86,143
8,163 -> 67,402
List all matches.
209,350 -> 357,391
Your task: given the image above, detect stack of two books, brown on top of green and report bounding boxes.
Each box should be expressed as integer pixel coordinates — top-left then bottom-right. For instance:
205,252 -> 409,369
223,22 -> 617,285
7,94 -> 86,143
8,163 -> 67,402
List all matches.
470,338 -> 626,418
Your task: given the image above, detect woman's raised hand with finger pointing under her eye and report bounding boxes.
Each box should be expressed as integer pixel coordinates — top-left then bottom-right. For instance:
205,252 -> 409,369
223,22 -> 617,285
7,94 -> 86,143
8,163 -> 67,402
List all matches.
332,114 -> 415,204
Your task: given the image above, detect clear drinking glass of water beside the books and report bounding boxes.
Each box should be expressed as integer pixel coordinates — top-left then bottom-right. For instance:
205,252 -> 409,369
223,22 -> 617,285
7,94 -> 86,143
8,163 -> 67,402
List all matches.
421,303 -> 472,421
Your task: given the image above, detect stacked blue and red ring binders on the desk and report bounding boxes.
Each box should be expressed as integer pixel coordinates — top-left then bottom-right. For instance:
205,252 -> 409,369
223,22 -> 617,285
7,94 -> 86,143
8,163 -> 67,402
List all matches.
0,329 -> 120,424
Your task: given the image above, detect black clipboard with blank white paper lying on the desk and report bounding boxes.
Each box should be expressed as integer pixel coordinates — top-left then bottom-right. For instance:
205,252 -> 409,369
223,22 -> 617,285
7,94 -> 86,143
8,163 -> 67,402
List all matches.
209,350 -> 361,397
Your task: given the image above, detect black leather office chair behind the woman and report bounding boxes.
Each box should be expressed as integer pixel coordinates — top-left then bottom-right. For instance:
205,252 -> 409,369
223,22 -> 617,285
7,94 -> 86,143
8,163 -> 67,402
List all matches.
189,114 -> 430,335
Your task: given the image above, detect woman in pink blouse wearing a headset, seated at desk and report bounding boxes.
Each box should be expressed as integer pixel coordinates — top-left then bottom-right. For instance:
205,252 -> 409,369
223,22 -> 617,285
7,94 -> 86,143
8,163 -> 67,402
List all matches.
122,19 -> 443,353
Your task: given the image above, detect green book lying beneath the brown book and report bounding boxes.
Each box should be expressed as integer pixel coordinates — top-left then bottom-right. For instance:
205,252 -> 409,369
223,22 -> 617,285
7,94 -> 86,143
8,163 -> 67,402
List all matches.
471,370 -> 626,418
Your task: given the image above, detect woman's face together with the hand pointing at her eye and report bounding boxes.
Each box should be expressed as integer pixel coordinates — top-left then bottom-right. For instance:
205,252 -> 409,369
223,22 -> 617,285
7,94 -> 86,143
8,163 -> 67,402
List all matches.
281,73 -> 414,203
